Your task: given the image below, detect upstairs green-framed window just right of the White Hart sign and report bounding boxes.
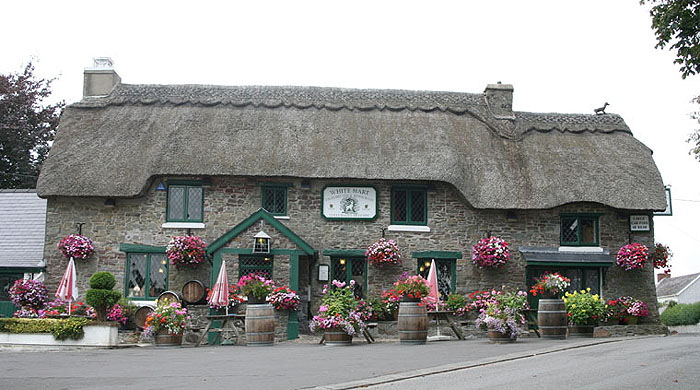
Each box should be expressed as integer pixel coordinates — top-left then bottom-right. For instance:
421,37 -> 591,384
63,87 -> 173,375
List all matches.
391,187 -> 428,225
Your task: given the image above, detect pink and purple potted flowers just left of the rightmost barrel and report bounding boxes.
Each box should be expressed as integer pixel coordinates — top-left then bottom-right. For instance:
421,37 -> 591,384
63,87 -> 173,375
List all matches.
474,291 -> 530,338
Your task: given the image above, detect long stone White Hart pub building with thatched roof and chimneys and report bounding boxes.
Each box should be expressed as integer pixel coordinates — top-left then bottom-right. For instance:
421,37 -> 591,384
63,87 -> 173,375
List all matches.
37,58 -> 666,337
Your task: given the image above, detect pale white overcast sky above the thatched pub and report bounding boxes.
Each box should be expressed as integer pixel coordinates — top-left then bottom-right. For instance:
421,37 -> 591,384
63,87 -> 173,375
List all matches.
0,0 -> 700,276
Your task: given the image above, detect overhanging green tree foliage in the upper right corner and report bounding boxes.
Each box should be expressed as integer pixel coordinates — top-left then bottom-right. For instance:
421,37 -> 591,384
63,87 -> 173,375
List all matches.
640,0 -> 700,161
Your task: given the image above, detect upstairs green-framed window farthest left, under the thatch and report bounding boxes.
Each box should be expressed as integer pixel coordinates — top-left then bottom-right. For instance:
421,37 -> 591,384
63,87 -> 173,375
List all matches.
166,182 -> 204,222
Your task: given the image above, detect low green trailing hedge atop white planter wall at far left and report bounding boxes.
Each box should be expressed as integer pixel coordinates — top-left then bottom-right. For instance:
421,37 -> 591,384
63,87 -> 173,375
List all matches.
0,317 -> 89,340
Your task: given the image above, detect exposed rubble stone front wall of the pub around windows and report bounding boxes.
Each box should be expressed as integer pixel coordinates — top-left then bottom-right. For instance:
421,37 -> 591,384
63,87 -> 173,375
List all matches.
45,177 -> 658,322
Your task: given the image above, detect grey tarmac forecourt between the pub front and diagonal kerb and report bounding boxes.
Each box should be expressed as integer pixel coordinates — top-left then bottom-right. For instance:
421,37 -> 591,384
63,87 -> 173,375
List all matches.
0,336 -> 688,390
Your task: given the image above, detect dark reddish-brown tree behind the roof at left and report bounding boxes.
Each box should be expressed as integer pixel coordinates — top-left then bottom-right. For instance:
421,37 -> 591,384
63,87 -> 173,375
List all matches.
0,62 -> 65,188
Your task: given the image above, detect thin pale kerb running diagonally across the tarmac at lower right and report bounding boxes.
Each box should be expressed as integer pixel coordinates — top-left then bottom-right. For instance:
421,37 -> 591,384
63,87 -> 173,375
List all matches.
306,335 -> 666,390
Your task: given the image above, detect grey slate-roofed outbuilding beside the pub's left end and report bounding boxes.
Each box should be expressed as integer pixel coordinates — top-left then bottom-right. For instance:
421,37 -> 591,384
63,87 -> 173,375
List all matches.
0,190 -> 46,316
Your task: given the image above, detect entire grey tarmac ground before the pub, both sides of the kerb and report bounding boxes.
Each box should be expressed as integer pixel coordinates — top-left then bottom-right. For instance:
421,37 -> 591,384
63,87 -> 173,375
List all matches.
0,336 -> 700,390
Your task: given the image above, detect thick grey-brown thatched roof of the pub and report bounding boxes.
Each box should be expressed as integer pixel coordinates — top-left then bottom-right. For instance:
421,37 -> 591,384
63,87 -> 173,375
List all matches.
37,84 -> 666,210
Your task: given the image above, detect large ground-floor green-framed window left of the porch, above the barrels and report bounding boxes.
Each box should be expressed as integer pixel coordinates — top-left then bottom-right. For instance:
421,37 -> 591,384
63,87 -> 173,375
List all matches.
124,251 -> 169,300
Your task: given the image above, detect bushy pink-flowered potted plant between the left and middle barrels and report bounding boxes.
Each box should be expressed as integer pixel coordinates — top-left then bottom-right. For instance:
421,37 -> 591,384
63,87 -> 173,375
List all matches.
309,280 -> 366,336
